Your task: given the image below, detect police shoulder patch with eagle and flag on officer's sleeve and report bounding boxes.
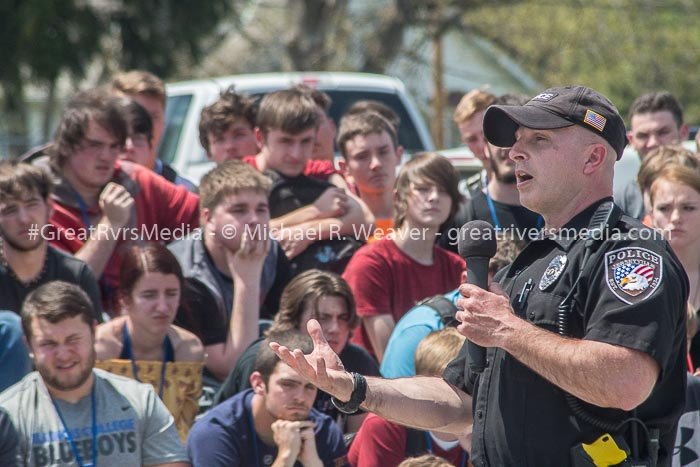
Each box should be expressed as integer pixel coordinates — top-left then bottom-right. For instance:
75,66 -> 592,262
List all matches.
605,247 -> 663,305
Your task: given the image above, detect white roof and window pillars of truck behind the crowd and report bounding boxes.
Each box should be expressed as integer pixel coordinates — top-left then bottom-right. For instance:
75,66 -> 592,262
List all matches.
159,72 -> 434,183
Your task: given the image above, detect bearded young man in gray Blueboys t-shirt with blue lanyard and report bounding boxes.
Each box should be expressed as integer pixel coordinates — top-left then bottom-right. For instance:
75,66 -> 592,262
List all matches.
0,281 -> 189,467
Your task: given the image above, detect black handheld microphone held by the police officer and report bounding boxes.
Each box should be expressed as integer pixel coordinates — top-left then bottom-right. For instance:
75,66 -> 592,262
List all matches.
457,221 -> 496,373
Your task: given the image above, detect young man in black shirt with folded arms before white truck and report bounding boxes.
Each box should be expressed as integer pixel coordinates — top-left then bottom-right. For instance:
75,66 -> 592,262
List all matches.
250,88 -> 373,272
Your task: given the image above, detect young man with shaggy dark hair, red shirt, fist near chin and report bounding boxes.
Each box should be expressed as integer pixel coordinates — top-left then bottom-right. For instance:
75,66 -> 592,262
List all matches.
45,90 -> 199,313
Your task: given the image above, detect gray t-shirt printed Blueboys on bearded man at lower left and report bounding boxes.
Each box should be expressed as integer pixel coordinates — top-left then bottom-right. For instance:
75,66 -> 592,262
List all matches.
0,369 -> 187,467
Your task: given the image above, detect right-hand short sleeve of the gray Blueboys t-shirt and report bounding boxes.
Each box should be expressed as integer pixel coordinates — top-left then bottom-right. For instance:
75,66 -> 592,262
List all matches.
141,387 -> 187,465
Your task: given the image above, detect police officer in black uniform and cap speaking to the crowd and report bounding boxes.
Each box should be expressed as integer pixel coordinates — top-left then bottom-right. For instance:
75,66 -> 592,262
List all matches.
273,87 -> 688,467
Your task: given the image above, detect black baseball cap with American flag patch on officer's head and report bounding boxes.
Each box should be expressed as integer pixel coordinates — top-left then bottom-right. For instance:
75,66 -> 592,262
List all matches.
484,86 -> 627,160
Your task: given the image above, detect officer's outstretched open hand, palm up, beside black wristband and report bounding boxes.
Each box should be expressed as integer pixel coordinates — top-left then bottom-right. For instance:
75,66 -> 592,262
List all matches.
270,319 -> 353,401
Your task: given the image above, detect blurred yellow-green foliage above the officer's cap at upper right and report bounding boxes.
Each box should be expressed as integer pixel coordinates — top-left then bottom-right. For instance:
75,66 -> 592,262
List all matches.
462,0 -> 700,122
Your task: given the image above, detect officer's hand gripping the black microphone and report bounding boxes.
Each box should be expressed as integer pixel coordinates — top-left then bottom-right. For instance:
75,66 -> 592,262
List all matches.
455,284 -> 518,347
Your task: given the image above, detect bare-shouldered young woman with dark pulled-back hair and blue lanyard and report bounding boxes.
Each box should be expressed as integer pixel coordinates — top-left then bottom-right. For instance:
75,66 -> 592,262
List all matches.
95,243 -> 204,441
